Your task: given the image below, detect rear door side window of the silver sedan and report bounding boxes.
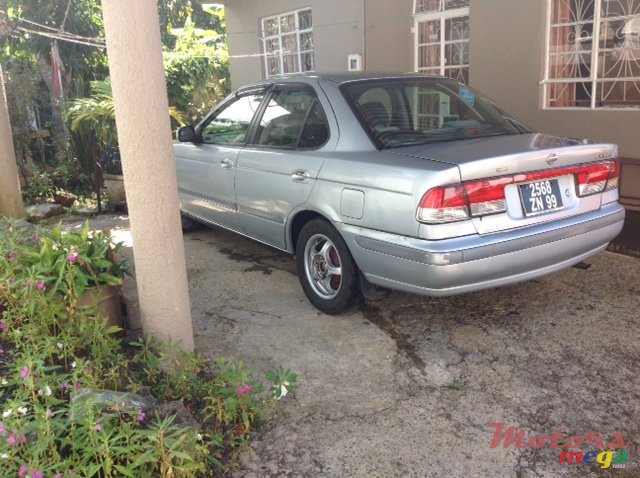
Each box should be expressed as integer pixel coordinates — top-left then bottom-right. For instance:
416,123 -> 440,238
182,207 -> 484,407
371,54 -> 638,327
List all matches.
256,87 -> 329,149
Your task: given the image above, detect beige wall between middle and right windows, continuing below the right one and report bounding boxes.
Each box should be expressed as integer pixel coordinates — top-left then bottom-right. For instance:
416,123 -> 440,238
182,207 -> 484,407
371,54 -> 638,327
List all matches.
470,0 -> 640,158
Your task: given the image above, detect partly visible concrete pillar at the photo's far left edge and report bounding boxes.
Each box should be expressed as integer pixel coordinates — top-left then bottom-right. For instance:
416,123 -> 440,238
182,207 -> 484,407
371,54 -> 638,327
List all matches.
0,65 -> 24,219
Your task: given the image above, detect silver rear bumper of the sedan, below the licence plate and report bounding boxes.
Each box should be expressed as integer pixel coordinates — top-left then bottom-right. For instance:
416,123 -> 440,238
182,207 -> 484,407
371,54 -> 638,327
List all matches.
336,203 -> 625,296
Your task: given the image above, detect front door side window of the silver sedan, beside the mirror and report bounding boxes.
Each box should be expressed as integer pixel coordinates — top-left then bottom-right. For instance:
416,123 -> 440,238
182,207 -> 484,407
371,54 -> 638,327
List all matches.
201,93 -> 264,144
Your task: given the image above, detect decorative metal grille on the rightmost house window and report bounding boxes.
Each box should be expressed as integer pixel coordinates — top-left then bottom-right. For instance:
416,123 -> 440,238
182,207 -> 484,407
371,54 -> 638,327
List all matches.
542,0 -> 640,109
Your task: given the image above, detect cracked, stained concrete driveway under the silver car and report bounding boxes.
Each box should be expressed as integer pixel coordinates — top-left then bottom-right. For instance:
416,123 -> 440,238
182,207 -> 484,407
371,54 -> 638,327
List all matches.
61,216 -> 640,478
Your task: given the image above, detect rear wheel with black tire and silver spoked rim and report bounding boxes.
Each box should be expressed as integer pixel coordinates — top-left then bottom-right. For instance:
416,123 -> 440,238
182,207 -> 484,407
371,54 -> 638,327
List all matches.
296,219 -> 360,315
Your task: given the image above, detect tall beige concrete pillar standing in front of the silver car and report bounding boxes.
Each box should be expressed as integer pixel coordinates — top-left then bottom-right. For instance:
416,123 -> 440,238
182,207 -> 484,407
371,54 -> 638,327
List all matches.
102,0 -> 194,350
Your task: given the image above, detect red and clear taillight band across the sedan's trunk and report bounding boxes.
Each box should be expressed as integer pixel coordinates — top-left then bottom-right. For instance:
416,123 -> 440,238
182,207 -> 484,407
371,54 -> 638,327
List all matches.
417,160 -> 620,224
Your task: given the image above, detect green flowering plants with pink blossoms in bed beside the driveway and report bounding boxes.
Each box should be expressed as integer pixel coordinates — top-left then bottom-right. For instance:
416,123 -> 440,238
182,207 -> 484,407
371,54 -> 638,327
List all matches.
0,220 -> 297,478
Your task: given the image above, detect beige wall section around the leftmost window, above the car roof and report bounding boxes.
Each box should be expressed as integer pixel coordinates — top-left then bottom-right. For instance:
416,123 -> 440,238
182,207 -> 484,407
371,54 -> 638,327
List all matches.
225,0 -> 413,88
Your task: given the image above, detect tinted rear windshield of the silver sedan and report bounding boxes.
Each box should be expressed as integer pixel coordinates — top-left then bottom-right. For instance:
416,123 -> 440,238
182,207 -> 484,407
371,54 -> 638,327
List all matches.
341,78 -> 532,149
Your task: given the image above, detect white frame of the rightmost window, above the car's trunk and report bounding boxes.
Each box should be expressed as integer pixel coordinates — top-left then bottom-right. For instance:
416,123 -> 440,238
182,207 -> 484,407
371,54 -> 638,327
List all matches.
540,0 -> 640,111
